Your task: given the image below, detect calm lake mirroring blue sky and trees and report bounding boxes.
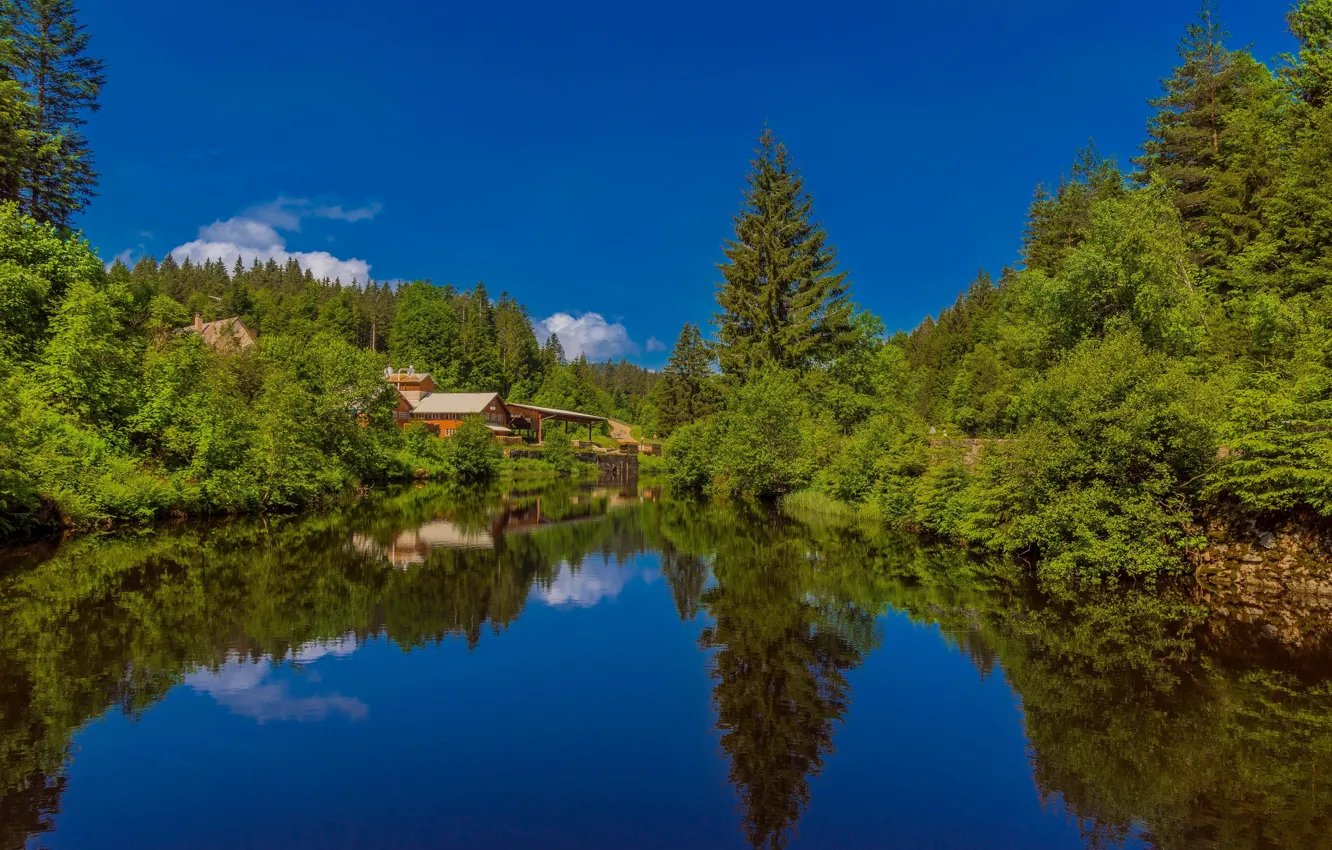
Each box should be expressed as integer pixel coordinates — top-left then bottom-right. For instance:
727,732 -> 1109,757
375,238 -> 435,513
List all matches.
0,484 -> 1332,850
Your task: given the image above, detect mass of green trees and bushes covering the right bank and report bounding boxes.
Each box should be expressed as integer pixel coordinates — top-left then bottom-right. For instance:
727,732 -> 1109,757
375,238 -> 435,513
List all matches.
659,0 -> 1332,586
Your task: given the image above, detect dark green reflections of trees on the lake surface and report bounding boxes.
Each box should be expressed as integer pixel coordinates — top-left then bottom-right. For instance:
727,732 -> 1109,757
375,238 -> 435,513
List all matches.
0,488 -> 1332,850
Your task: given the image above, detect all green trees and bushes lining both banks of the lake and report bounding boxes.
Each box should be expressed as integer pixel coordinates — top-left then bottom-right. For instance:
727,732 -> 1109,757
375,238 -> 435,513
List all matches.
0,0 -> 1332,591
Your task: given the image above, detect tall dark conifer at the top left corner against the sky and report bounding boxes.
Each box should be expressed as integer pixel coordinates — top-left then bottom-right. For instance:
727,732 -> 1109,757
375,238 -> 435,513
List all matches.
5,0 -> 105,225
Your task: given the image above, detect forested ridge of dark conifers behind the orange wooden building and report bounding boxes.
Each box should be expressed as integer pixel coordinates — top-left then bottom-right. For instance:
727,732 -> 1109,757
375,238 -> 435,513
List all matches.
137,256 -> 657,422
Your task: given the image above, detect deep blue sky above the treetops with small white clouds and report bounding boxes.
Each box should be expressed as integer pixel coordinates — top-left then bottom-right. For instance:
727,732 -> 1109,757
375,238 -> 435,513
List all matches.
79,0 -> 1291,365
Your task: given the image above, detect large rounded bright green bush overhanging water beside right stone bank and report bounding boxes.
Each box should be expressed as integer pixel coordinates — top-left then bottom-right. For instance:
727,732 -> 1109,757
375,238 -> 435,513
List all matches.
953,332 -> 1221,578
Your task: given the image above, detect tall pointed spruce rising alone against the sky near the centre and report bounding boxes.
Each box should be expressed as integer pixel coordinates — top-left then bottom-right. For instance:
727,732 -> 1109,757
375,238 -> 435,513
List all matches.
715,129 -> 852,376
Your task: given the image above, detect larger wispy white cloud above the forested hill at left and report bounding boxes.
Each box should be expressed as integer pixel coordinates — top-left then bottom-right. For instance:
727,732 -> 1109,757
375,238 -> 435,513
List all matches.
170,196 -> 380,284
